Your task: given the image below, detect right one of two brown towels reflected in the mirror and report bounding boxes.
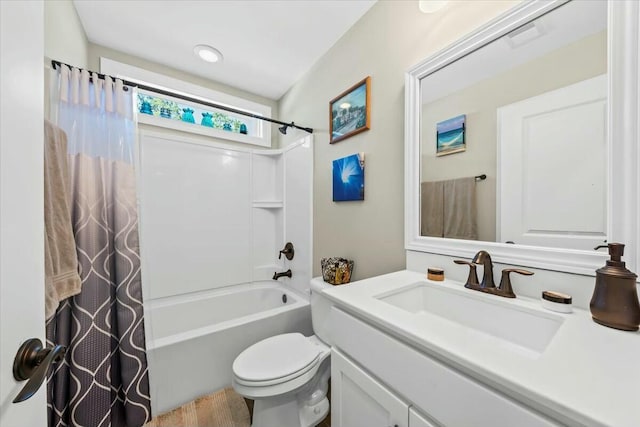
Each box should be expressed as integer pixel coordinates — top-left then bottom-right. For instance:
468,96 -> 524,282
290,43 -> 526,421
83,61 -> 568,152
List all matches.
443,177 -> 478,240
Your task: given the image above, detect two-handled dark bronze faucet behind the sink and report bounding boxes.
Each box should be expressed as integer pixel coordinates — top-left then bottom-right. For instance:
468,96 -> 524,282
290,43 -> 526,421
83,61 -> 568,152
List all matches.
453,251 -> 533,298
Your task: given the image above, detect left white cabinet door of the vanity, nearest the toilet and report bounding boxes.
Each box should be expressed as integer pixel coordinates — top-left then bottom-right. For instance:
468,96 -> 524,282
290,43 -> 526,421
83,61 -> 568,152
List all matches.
331,350 -> 409,427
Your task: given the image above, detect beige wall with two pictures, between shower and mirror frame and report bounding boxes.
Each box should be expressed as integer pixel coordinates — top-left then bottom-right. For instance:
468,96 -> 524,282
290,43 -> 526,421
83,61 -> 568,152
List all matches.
280,1 -> 517,280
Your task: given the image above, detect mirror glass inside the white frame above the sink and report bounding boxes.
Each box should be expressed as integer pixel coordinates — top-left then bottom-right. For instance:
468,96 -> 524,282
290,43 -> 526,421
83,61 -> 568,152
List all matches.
420,1 -> 608,250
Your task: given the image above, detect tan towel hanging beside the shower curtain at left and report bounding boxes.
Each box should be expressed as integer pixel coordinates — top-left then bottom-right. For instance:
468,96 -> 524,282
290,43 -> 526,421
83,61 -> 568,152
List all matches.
44,120 -> 81,319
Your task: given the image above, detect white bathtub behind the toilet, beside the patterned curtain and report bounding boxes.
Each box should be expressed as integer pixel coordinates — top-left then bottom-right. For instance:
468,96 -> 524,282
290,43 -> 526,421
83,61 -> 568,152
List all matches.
145,282 -> 313,415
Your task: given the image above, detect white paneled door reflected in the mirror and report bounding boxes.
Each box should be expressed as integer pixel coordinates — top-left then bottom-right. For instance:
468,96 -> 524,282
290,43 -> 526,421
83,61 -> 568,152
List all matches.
496,75 -> 608,250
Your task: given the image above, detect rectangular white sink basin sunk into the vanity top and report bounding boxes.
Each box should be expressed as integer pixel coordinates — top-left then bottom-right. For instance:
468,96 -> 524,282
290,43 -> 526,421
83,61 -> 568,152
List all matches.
375,282 -> 563,355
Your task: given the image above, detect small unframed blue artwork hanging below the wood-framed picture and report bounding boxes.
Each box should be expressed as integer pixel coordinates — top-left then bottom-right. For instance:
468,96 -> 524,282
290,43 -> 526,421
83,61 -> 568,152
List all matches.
333,153 -> 364,202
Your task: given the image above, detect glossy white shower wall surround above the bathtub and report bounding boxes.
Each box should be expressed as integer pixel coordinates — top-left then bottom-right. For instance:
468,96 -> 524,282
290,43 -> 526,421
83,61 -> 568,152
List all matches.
139,131 -> 313,302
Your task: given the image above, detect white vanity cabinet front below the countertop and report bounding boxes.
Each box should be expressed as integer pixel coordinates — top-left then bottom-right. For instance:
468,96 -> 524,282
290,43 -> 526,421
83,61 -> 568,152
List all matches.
331,307 -> 563,427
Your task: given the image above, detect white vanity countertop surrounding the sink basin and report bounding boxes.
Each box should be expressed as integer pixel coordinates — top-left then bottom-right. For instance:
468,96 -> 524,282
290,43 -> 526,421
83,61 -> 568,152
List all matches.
325,270 -> 640,427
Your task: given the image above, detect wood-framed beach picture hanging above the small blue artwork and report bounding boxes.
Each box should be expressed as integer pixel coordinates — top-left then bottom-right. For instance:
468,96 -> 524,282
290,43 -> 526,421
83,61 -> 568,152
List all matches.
329,77 -> 371,144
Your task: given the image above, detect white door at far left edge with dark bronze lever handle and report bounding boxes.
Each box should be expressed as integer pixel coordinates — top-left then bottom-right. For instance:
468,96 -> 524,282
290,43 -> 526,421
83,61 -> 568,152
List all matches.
0,1 -> 47,427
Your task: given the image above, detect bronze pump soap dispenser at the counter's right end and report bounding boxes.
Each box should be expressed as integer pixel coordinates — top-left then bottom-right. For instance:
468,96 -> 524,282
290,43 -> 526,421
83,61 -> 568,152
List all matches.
590,243 -> 640,331
